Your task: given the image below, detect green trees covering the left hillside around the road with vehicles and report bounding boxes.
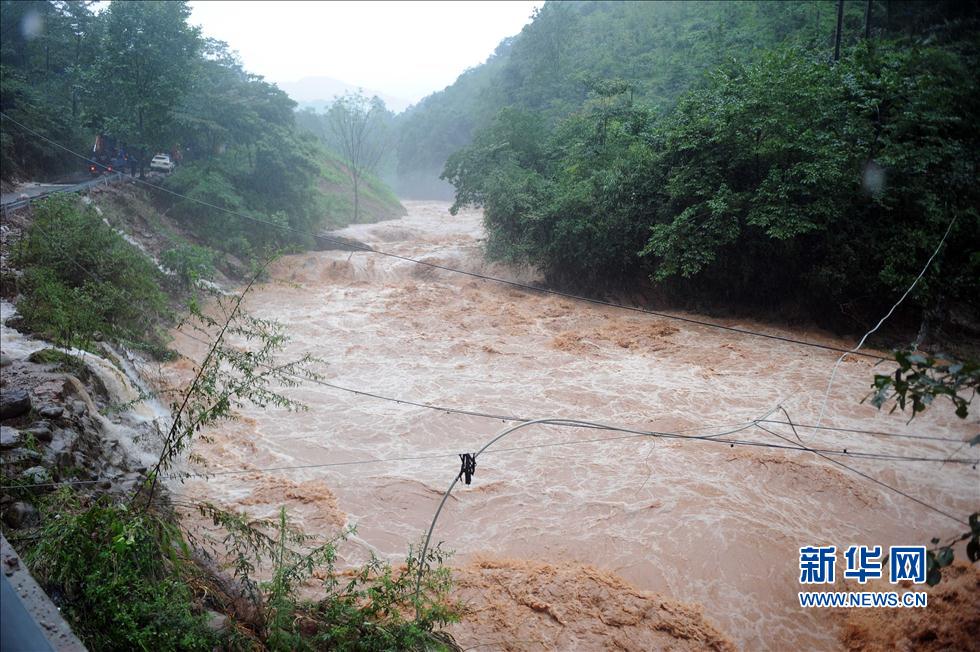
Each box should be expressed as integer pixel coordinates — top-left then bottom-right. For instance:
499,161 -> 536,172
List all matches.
0,1 -> 401,258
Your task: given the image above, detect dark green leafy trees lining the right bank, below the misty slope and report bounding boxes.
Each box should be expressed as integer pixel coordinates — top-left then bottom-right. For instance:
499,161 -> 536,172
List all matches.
443,43 -> 980,325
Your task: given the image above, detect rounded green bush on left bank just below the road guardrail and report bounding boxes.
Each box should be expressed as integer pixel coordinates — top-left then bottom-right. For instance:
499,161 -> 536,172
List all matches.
15,196 -> 169,348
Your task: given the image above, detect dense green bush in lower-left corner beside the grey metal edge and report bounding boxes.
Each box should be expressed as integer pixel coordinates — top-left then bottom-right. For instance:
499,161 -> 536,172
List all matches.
27,490 -> 216,650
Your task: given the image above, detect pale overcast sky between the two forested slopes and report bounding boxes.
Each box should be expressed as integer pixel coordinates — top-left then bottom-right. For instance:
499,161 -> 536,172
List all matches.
190,0 -> 544,102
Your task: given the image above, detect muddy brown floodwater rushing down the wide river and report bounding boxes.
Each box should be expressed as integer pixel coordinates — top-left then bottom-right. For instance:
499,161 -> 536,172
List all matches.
165,202 -> 980,650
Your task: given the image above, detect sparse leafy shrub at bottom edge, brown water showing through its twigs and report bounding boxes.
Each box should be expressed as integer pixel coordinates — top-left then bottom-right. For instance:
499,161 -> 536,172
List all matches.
199,503 -> 459,651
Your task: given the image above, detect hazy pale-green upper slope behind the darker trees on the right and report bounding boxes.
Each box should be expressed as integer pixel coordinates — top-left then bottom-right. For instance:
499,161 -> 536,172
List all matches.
398,2 -> 863,197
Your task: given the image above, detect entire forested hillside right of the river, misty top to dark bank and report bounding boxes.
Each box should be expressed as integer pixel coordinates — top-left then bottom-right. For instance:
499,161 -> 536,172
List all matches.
399,2 -> 980,336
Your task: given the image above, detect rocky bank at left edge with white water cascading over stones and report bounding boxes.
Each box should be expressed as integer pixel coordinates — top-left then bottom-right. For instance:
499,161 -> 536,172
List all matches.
0,304 -> 156,528
